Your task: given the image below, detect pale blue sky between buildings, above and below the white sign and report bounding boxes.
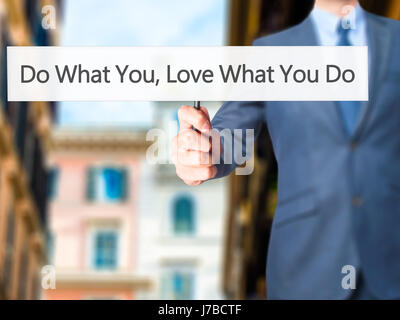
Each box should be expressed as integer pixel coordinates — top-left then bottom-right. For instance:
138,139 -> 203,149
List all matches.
58,0 -> 228,128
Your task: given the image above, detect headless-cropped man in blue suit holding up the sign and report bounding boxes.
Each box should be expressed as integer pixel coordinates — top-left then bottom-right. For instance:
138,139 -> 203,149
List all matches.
173,0 -> 400,299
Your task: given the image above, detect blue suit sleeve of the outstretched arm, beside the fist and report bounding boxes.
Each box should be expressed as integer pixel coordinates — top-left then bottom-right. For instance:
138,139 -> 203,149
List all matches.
211,101 -> 265,179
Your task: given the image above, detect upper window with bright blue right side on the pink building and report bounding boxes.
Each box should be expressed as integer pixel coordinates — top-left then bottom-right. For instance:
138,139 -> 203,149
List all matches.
86,167 -> 128,202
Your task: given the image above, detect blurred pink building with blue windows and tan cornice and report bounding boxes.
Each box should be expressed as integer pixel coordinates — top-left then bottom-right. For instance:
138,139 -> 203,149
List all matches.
44,129 -> 150,299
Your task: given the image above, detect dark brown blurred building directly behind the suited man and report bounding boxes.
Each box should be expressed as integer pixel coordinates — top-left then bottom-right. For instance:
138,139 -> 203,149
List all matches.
223,0 -> 400,299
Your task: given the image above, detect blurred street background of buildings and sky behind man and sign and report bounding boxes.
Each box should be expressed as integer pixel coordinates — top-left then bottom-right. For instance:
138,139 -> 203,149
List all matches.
0,0 -> 400,299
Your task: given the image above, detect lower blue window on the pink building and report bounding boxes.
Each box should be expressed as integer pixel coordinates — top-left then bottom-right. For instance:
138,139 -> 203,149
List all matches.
93,230 -> 118,270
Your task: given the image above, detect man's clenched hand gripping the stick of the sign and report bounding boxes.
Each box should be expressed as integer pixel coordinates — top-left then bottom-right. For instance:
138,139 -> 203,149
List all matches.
172,106 -> 220,186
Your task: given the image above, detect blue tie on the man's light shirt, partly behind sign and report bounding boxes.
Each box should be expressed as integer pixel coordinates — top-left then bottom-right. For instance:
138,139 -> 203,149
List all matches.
337,21 -> 361,136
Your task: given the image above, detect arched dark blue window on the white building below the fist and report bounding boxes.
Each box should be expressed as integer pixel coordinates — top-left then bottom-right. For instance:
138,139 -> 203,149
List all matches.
172,195 -> 195,235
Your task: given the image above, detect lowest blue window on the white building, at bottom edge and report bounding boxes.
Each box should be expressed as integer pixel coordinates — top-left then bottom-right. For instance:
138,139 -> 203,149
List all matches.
161,267 -> 194,300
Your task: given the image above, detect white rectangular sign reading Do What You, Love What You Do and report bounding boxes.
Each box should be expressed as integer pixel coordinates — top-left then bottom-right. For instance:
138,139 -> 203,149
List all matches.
7,46 -> 368,101
